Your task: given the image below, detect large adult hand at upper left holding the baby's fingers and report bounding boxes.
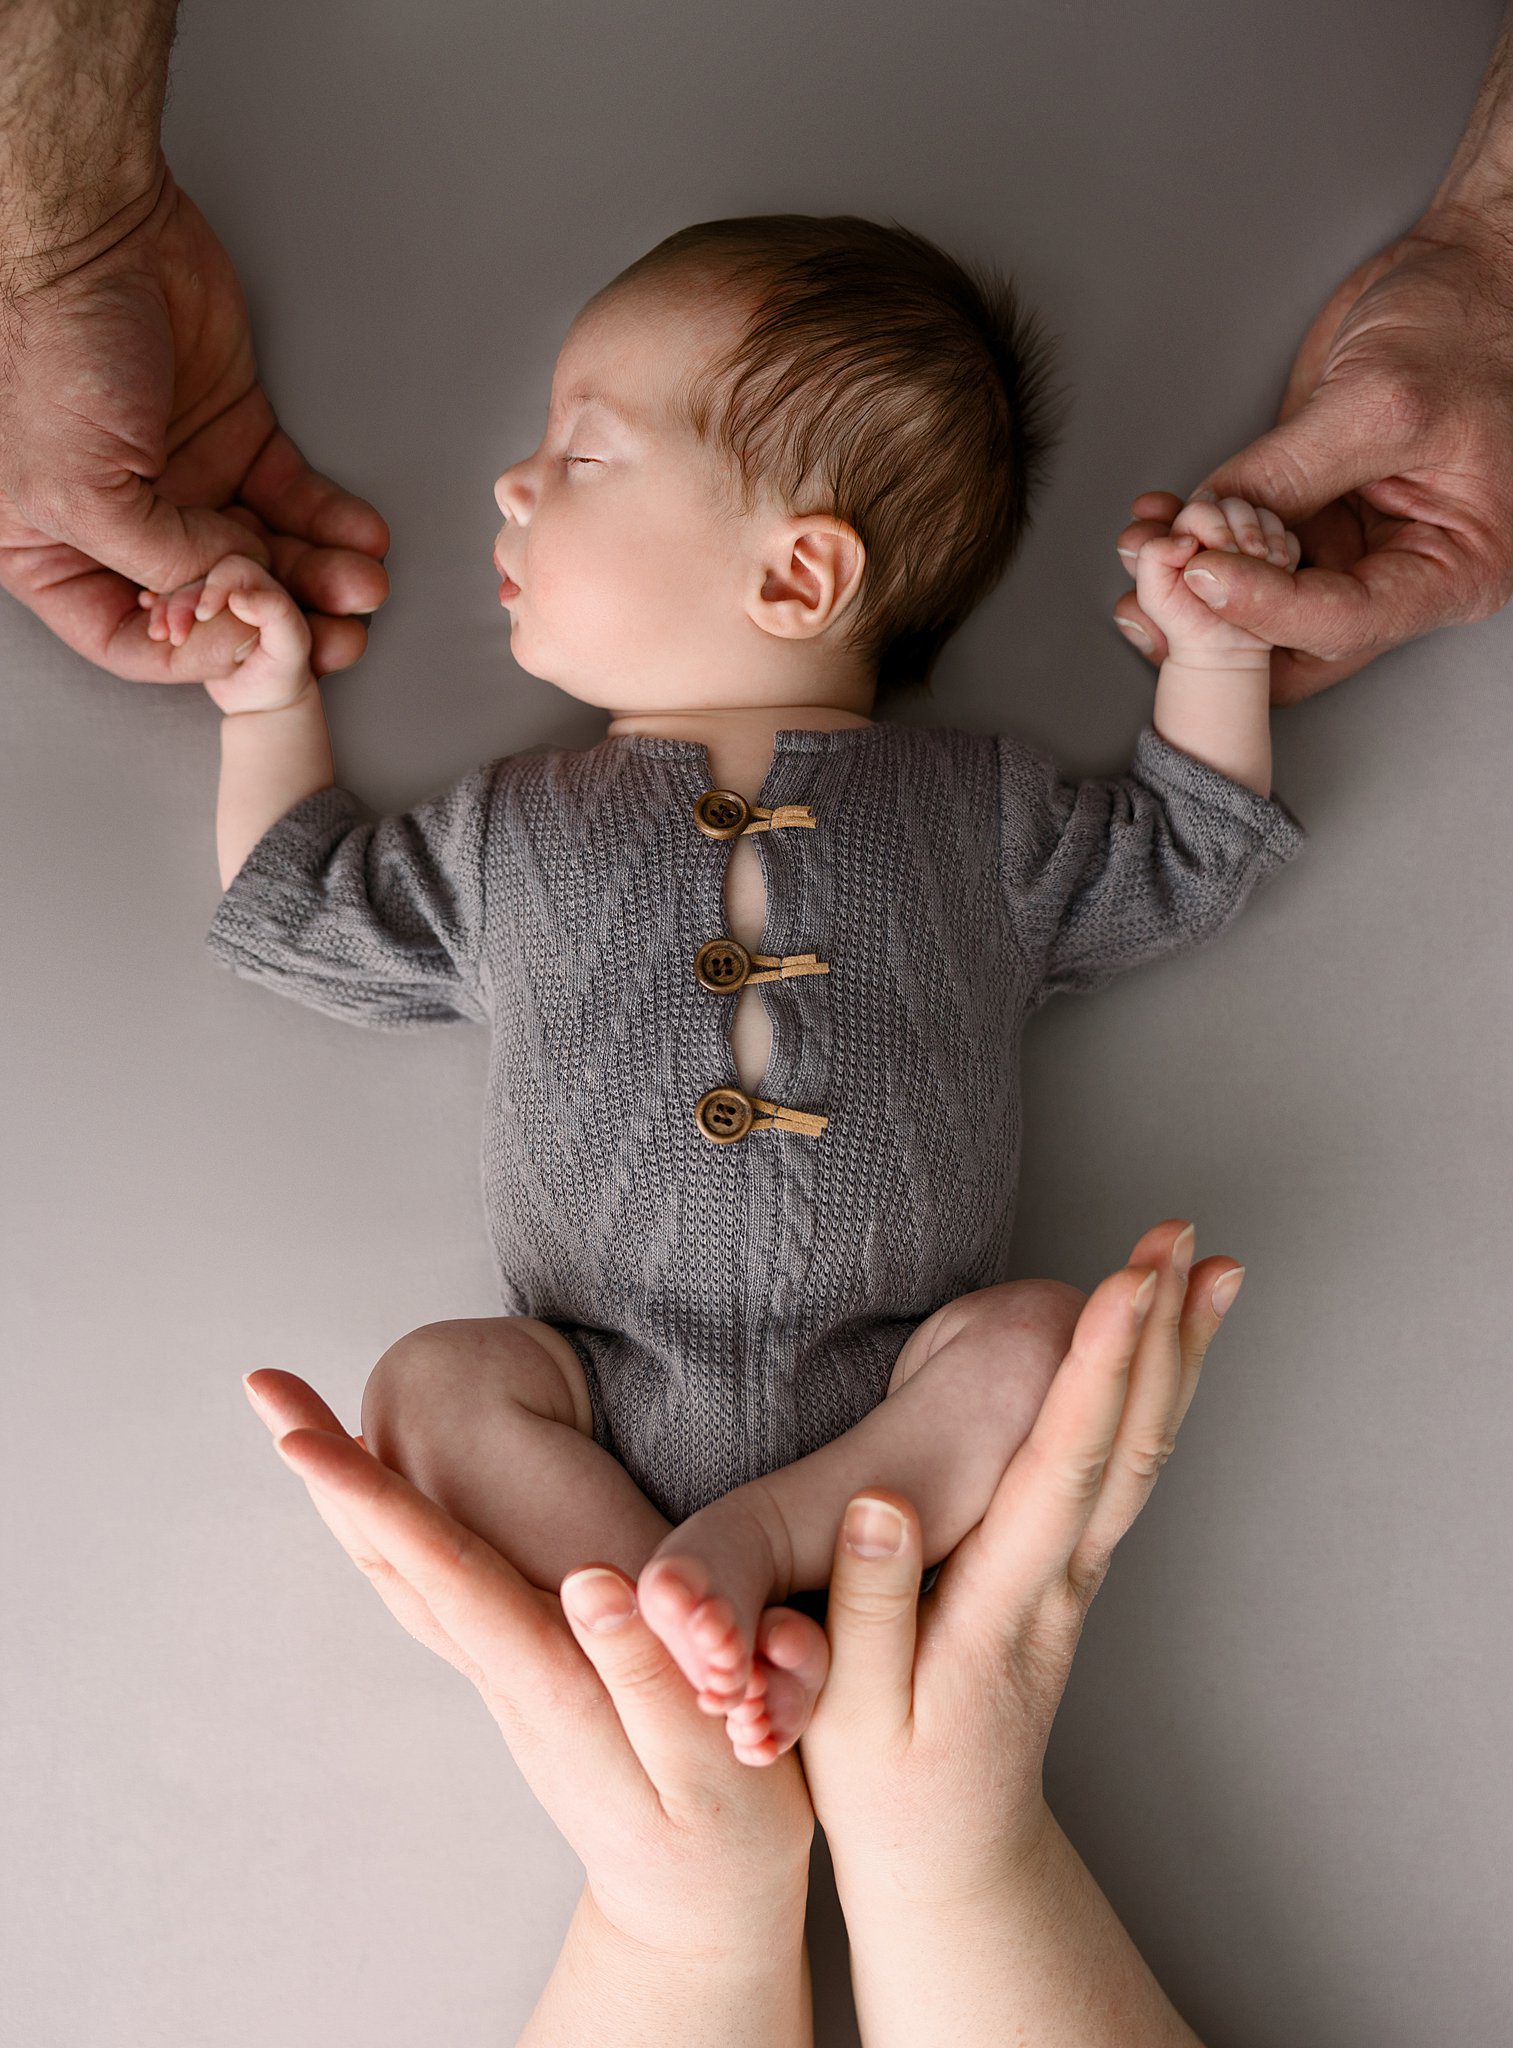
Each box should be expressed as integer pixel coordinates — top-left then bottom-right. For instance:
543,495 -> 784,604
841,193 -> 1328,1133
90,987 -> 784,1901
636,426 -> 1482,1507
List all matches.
0,154 -> 389,684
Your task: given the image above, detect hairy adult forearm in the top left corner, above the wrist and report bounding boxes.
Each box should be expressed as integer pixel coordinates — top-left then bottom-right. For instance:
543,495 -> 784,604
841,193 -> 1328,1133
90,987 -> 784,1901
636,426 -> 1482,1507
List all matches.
0,0 -> 178,262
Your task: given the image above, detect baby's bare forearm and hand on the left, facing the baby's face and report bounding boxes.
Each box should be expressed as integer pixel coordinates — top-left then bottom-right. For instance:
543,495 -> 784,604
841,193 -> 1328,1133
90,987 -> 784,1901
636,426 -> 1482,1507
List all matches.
141,555 -> 336,889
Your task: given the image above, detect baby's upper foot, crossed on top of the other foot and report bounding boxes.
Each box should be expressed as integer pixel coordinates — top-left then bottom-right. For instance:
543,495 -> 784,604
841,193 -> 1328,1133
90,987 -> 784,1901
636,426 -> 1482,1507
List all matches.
637,1487 -> 788,1714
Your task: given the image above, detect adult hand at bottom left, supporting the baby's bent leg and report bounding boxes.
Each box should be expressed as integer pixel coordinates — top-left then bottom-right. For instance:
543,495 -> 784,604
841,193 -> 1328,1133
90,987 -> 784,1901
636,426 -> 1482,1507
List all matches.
246,1370 -> 815,1958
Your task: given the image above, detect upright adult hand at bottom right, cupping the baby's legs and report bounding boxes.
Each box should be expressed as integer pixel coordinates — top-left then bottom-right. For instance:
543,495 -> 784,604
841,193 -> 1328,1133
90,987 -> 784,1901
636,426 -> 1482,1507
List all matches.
798,1223 -> 1243,1919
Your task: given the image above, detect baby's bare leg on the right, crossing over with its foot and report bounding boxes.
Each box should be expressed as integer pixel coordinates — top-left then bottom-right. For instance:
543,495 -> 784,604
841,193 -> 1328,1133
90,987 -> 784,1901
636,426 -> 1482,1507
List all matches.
637,1280 -> 1087,1735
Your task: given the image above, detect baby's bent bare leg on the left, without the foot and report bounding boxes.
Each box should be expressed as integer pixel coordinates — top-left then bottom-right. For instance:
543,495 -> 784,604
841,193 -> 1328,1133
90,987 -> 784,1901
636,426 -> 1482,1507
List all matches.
362,1315 -> 672,1593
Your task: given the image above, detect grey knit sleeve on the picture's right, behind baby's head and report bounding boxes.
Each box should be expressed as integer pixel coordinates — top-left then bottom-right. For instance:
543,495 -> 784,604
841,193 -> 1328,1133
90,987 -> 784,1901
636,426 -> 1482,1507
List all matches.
999,725 -> 1306,1008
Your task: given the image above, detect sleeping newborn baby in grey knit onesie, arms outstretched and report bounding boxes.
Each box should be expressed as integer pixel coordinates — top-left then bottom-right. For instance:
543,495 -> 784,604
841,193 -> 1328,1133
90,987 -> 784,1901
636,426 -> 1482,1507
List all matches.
143,215 -> 1302,1763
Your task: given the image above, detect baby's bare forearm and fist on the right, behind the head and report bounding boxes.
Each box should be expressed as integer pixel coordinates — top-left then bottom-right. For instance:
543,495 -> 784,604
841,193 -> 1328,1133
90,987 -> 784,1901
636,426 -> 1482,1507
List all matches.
1134,494 -> 1302,797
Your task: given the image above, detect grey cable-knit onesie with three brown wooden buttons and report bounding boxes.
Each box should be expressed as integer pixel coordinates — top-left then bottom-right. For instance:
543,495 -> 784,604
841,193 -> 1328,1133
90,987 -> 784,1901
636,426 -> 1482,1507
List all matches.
207,723 -> 1304,1522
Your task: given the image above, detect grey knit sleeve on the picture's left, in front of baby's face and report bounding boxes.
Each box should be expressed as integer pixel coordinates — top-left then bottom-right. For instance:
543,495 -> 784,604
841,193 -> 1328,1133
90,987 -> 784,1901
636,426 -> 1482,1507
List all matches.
207,762 -> 495,1030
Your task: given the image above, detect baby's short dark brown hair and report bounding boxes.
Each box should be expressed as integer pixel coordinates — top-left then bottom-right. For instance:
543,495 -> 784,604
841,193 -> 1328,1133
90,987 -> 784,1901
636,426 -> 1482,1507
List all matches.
596,213 -> 1067,702
